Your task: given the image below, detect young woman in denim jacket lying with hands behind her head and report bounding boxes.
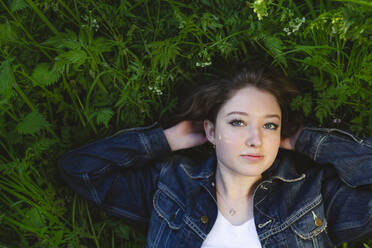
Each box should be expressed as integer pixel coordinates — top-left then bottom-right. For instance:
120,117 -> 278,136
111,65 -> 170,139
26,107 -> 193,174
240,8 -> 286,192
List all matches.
59,70 -> 372,248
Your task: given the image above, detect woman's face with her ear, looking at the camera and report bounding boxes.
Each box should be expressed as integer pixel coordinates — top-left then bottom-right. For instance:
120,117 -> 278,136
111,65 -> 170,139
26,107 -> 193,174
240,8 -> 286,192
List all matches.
204,86 -> 282,177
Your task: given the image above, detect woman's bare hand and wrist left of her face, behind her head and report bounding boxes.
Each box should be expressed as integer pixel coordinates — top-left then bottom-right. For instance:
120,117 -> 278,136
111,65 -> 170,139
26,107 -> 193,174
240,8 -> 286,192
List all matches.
164,121 -> 207,151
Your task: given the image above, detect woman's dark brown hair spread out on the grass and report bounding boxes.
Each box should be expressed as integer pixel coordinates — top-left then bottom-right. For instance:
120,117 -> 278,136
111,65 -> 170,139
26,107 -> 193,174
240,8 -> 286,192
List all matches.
177,68 -> 303,138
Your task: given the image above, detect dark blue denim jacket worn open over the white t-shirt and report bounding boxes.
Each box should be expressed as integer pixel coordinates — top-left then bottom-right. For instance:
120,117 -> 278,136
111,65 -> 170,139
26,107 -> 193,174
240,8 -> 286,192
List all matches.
59,123 -> 372,248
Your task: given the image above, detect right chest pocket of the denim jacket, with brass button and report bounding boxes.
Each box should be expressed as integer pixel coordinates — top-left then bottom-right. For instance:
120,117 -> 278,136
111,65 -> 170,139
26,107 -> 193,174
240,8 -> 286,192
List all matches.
291,199 -> 327,240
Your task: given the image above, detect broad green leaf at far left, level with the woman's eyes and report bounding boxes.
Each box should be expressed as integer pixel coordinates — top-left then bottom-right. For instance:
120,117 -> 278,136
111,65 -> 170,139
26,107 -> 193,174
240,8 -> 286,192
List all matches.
17,111 -> 50,134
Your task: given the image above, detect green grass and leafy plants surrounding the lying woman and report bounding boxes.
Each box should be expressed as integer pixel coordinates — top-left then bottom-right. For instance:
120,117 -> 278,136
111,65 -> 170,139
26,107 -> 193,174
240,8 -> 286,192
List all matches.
0,0 -> 372,247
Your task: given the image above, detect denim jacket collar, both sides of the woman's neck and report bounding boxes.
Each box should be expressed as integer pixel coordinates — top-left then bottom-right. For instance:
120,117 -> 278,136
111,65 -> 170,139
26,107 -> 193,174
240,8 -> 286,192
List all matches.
181,149 -> 306,182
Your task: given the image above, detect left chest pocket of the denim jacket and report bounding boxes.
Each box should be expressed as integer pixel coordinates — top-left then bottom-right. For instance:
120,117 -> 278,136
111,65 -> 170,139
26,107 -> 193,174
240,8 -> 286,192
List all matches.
154,189 -> 184,230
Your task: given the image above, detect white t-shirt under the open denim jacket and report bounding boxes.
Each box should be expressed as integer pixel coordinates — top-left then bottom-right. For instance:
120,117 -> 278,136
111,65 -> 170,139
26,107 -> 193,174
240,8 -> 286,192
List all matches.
201,211 -> 261,248
